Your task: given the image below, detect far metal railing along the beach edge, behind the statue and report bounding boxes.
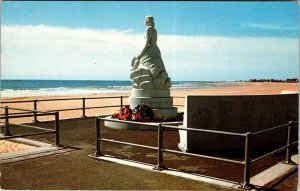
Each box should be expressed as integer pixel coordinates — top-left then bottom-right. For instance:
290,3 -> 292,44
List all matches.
1,96 -> 185,122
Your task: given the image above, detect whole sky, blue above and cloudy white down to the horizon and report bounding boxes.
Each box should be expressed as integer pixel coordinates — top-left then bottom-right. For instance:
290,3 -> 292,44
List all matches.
1,1 -> 299,80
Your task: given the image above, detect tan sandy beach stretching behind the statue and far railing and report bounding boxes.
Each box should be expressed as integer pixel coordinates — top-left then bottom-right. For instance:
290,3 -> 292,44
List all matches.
1,82 -> 299,122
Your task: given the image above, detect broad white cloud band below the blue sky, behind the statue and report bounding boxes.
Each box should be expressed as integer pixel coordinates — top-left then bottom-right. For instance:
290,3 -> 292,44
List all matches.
1,25 -> 299,80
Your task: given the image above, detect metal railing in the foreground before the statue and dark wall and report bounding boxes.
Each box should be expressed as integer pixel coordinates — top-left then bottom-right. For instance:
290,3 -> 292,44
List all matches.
94,117 -> 298,189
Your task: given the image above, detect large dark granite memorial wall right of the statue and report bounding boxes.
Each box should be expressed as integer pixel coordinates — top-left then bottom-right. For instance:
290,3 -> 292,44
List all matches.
179,94 -> 298,151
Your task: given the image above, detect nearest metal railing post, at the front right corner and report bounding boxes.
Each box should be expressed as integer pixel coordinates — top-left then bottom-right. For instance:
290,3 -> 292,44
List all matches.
242,132 -> 251,190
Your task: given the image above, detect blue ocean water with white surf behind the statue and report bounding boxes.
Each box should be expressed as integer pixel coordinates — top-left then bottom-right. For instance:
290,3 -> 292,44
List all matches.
0,80 -> 239,98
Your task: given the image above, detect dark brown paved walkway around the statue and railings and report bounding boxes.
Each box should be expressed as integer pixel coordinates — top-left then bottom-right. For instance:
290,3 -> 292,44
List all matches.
0,119 -> 298,190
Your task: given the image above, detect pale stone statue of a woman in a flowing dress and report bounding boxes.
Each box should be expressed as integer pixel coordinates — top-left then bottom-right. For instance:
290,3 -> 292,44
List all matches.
130,16 -> 171,90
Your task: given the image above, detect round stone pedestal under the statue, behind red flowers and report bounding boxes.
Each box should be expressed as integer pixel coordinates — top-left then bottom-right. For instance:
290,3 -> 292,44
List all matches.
129,88 -> 178,120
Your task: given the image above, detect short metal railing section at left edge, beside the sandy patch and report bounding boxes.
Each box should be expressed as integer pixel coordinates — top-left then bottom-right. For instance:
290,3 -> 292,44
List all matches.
0,106 -> 61,146
